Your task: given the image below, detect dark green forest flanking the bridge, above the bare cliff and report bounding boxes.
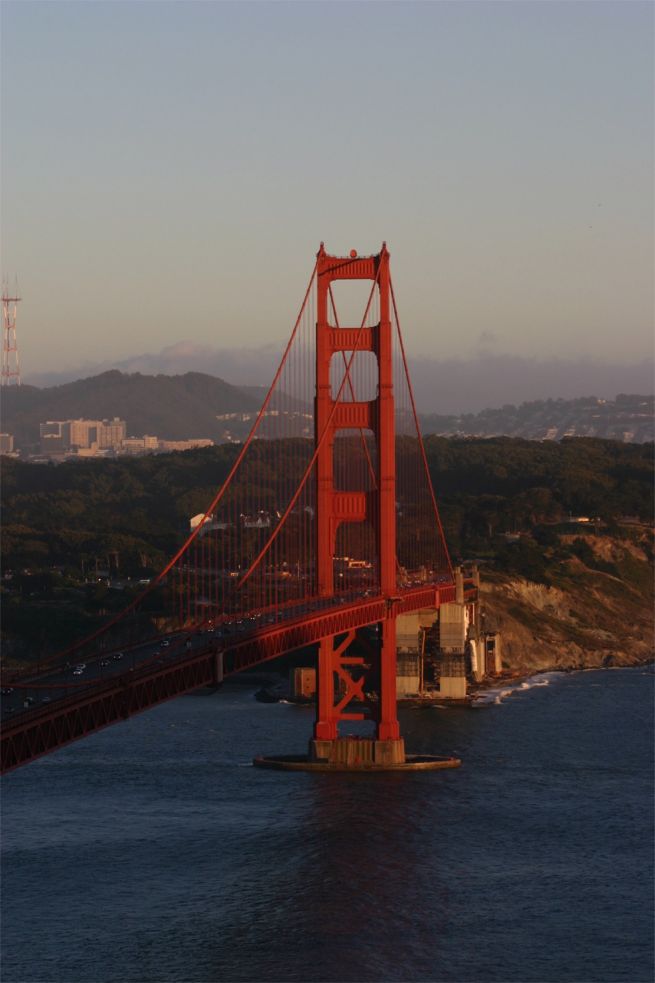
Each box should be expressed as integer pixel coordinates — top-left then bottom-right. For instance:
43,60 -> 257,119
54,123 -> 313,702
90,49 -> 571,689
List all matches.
2,437 -> 653,575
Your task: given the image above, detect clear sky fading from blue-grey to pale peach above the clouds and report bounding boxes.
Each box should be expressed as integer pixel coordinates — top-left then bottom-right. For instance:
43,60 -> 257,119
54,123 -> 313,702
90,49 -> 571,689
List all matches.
1,0 -> 653,381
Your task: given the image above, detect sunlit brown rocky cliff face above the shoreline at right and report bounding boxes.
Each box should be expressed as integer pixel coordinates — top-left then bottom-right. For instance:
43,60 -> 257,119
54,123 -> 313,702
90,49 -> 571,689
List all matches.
481,531 -> 655,672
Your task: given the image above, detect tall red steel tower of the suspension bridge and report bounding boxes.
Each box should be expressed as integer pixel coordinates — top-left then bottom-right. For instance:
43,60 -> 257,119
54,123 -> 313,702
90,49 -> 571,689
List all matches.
310,244 -> 405,764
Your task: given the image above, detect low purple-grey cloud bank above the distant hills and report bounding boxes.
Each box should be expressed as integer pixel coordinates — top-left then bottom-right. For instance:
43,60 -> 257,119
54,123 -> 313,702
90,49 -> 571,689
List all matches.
25,338 -> 655,413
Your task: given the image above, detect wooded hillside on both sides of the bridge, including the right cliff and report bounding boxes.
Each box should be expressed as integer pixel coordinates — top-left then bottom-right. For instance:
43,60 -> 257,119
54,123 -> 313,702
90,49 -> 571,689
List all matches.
2,437 -> 653,658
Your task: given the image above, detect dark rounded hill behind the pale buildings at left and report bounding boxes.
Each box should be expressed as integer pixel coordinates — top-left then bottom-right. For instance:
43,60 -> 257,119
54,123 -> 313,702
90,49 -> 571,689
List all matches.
1,370 -> 260,447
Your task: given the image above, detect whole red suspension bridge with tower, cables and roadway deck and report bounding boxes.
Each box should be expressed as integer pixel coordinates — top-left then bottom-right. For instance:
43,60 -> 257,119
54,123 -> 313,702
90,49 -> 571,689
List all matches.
1,243 -> 472,772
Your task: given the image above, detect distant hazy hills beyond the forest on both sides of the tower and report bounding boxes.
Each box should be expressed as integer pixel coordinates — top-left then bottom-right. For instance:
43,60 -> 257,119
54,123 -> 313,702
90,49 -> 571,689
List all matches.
0,369 -> 654,448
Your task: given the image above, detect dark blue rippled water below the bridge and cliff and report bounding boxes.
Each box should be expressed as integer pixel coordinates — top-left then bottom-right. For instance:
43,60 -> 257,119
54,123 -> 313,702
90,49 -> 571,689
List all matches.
2,669 -> 653,983
